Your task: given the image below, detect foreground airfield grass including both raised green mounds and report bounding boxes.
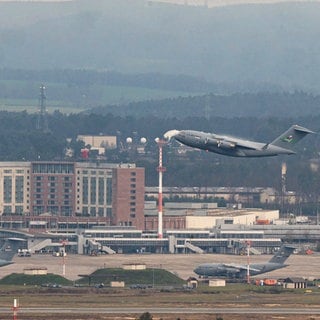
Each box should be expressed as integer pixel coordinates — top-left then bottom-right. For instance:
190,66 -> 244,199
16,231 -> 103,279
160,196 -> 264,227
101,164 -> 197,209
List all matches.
0,268 -> 320,320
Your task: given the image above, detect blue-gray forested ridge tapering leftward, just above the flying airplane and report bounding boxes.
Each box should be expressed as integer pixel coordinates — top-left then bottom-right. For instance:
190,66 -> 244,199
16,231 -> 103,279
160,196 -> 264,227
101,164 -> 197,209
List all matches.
90,92 -> 320,119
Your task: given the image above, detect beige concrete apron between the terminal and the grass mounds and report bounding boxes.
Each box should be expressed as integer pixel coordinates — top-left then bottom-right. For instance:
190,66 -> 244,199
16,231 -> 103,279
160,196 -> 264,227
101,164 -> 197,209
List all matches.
0,254 -> 320,280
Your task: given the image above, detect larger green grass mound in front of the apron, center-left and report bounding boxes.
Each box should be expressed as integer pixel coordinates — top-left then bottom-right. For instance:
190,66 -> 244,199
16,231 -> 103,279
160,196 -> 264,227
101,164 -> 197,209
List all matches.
77,268 -> 185,286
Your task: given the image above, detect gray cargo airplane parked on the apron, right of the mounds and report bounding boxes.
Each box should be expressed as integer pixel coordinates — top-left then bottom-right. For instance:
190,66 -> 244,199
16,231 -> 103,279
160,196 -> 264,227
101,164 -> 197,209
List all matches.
194,245 -> 296,279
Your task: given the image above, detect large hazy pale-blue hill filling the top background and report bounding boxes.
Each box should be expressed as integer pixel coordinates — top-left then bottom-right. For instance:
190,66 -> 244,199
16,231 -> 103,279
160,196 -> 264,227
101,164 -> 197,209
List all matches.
0,0 -> 320,93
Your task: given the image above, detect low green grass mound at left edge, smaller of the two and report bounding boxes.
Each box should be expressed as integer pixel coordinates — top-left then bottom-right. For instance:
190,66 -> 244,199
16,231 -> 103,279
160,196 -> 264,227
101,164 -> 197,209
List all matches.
0,273 -> 73,286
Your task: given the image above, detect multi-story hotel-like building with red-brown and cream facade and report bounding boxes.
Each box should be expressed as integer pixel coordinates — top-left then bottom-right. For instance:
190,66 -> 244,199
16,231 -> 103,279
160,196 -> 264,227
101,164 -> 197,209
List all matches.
0,161 -> 144,229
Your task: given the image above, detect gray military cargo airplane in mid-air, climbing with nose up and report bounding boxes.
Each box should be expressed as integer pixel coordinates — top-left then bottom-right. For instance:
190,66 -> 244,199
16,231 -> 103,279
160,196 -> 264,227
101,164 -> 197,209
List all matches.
164,125 -> 314,157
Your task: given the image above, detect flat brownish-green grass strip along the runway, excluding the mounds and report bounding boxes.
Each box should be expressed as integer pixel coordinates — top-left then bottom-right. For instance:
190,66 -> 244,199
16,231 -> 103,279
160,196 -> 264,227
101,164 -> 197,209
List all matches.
0,279 -> 320,320
